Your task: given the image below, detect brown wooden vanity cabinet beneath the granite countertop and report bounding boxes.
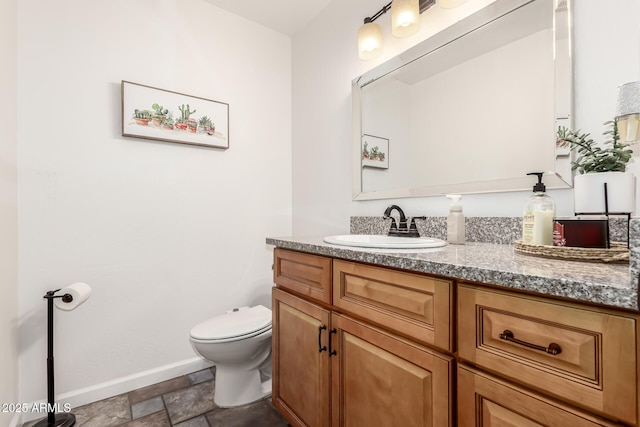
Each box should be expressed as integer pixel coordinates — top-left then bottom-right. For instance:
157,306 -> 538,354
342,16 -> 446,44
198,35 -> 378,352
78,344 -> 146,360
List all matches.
272,248 -> 640,427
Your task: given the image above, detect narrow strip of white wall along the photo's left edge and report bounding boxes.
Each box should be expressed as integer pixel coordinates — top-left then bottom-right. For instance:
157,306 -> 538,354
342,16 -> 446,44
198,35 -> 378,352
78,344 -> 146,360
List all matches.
0,0 -> 18,426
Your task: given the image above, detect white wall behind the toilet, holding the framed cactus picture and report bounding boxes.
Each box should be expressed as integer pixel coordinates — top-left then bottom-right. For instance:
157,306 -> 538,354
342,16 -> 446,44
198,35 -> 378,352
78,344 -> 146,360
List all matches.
17,0 -> 291,414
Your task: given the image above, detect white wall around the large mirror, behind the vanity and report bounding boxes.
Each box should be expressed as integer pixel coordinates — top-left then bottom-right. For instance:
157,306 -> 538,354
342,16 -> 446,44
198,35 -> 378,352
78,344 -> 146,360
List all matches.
293,0 -> 640,235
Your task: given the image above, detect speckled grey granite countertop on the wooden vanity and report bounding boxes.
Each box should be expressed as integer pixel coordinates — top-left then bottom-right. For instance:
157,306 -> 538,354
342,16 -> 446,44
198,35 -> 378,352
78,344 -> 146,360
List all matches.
266,237 -> 639,310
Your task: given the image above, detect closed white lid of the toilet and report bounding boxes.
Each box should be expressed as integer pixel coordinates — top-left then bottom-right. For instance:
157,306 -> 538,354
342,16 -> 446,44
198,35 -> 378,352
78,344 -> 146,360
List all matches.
191,305 -> 271,340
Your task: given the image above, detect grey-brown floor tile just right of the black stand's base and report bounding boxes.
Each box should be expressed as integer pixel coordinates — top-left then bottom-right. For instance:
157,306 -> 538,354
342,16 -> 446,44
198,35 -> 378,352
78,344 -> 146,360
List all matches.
72,394 -> 131,427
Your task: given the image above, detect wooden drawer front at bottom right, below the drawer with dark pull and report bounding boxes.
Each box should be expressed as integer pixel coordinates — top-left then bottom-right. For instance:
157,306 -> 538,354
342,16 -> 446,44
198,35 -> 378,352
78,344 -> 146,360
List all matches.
458,365 -> 618,427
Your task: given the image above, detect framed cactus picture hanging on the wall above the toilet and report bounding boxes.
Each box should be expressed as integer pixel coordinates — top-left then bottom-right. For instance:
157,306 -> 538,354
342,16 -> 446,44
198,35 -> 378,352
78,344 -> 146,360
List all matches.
121,80 -> 229,149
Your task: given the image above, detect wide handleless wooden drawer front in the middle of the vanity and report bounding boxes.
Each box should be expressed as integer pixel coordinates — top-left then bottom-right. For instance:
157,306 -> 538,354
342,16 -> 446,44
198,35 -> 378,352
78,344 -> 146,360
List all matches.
333,260 -> 453,351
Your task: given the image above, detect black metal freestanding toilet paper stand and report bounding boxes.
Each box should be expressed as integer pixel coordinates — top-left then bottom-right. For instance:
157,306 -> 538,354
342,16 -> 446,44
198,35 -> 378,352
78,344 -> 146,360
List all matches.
35,289 -> 76,427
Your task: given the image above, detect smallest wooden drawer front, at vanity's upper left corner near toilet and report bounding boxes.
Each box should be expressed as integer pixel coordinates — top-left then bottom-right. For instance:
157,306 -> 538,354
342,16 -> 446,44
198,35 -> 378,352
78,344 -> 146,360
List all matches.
273,248 -> 331,304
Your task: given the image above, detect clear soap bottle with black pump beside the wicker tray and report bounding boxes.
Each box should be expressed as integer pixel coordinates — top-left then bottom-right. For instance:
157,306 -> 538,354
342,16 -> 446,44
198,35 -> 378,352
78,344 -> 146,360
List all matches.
522,172 -> 555,245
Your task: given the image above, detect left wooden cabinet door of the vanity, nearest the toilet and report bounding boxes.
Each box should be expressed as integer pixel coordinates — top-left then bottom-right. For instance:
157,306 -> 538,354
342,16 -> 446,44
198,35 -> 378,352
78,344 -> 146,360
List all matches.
272,288 -> 331,427
